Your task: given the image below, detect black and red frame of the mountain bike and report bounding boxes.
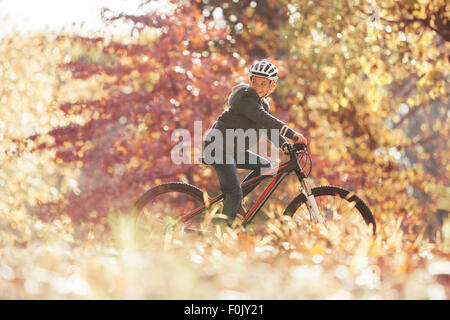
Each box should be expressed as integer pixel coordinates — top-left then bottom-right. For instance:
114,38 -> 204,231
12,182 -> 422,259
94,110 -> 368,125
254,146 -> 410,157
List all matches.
181,150 -> 315,226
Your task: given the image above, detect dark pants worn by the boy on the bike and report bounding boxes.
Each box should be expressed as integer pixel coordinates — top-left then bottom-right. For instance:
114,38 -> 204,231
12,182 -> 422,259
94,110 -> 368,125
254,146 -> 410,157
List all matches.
213,150 -> 272,221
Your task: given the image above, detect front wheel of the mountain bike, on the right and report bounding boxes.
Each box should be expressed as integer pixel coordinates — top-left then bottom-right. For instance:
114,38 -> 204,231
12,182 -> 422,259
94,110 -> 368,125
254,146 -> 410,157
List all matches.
284,186 -> 376,236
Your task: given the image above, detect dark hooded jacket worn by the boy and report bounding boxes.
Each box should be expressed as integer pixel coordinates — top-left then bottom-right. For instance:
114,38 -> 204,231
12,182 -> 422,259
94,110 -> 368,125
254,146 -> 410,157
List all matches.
205,84 -> 294,155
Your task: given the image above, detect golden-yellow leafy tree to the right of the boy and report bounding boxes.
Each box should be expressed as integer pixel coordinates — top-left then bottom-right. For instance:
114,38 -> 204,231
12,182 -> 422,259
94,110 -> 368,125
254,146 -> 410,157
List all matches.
272,1 -> 449,235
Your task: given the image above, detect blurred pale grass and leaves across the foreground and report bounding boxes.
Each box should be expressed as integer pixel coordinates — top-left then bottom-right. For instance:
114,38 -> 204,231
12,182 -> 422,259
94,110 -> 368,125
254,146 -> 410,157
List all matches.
0,210 -> 450,299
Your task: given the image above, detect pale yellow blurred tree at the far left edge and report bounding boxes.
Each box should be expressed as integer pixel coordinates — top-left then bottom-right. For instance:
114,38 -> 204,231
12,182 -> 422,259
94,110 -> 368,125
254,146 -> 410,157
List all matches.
0,33 -> 80,220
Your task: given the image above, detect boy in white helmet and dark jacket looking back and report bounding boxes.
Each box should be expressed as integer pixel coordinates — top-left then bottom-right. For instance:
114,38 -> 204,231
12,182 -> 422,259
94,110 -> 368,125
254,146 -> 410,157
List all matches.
204,60 -> 307,225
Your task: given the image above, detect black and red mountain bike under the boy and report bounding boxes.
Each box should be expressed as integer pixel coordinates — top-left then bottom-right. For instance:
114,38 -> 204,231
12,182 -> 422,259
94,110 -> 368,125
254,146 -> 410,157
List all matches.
132,143 -> 376,235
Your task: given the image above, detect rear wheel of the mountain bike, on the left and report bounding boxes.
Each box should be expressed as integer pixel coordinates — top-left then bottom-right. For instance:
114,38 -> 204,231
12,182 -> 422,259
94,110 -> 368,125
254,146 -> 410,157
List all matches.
131,182 -> 205,234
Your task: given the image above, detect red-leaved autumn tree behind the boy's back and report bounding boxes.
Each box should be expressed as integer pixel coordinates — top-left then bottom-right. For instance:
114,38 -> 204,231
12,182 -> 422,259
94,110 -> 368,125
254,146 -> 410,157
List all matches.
21,3 -> 239,223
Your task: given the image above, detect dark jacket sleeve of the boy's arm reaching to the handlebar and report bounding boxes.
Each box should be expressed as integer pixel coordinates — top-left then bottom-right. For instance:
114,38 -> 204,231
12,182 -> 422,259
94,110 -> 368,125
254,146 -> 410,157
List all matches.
235,91 -> 294,140
